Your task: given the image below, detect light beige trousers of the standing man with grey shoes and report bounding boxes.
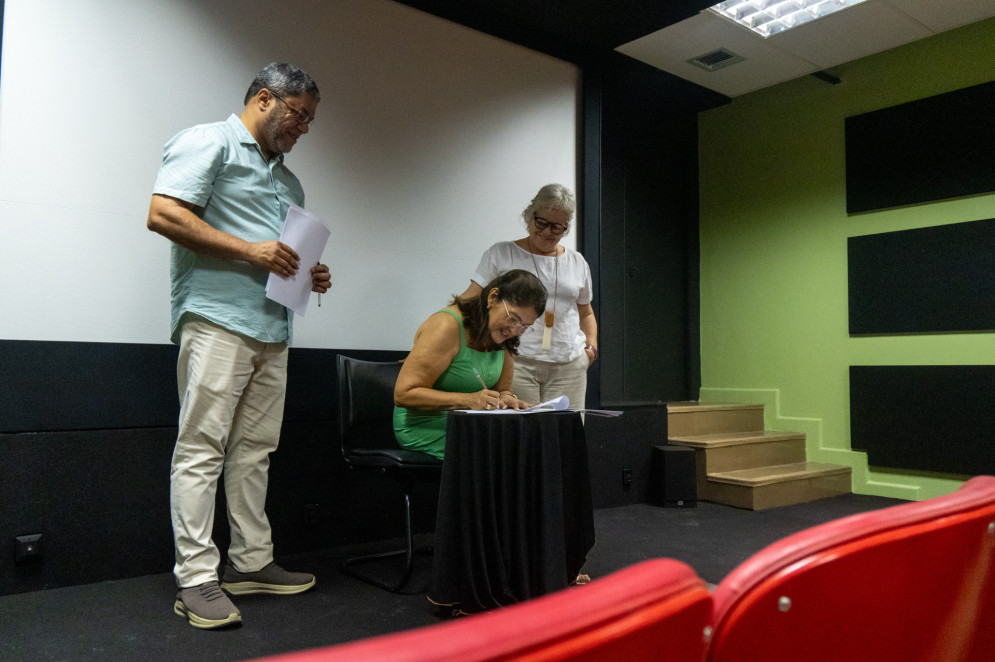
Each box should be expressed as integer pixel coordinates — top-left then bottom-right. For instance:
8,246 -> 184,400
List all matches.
169,317 -> 287,588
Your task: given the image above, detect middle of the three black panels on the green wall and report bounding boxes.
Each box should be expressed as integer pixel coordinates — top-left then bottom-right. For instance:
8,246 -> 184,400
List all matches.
847,219 -> 995,334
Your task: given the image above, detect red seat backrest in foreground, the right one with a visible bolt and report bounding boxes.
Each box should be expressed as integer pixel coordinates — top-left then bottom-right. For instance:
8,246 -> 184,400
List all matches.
708,476 -> 995,662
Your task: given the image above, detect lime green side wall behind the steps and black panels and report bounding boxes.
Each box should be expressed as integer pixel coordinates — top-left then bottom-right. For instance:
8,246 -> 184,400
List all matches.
699,19 -> 995,499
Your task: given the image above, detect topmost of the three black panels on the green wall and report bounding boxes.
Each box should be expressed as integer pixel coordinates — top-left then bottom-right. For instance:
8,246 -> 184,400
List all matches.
846,82 -> 995,214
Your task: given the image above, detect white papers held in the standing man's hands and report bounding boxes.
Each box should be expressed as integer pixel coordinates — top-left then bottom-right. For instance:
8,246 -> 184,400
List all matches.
266,205 -> 331,317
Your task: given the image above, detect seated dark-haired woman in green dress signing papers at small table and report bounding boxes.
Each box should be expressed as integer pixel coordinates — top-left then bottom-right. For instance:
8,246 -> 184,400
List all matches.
394,269 -> 548,459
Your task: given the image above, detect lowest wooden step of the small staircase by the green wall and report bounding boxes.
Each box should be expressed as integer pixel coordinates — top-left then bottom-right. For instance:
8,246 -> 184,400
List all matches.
699,462 -> 851,510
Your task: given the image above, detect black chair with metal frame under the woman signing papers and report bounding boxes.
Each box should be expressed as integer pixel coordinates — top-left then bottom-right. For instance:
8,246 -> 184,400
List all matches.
338,354 -> 442,593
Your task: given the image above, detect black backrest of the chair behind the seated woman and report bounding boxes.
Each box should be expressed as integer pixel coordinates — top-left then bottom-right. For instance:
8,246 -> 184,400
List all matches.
338,354 -> 401,460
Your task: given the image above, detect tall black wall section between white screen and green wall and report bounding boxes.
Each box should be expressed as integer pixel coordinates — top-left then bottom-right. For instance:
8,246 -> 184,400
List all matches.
581,55 -> 725,408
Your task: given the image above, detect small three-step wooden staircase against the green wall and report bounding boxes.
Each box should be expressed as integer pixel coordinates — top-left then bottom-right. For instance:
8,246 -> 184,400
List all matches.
667,402 -> 851,510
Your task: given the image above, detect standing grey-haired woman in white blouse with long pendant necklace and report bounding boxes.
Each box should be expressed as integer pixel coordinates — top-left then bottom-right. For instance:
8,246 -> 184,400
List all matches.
461,184 -> 598,409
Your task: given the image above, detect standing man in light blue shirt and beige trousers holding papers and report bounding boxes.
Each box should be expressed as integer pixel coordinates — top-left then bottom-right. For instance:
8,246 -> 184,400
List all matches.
148,63 -> 331,629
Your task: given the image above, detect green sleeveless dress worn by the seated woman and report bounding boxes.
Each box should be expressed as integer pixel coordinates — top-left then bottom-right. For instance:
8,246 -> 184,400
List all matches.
394,309 -> 504,460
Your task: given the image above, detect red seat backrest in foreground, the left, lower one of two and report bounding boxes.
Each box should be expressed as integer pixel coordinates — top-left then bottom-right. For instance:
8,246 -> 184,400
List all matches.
249,559 -> 711,662
